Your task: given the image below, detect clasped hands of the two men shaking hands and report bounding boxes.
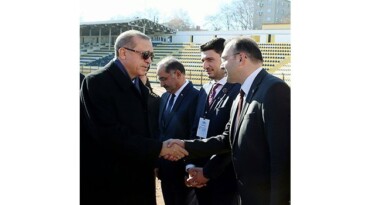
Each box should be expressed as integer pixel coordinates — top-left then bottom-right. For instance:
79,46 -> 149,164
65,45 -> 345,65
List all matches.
160,139 -> 189,161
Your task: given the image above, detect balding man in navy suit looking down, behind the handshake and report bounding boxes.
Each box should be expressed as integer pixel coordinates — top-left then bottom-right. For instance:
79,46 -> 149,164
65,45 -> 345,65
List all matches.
157,57 -> 199,205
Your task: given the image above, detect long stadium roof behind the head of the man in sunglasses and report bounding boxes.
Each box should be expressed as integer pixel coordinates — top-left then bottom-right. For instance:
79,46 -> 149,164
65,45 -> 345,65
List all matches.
80,18 -> 176,36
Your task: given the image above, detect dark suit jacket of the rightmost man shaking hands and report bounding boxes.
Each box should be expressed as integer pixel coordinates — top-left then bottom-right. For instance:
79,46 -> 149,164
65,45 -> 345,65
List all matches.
185,70 -> 290,205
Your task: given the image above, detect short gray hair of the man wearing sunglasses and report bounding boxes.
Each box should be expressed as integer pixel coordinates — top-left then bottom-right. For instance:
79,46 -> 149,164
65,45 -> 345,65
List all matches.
114,30 -> 151,58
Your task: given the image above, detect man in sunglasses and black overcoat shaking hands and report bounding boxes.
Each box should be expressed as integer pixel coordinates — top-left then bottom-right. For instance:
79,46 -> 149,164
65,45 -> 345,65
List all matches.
80,30 -> 188,205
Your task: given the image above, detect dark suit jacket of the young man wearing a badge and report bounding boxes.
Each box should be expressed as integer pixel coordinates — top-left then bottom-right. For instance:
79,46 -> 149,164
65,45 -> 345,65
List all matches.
192,83 -> 241,193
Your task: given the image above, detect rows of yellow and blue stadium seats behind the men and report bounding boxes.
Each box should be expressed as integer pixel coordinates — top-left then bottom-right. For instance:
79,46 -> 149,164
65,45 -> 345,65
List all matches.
80,43 -> 291,86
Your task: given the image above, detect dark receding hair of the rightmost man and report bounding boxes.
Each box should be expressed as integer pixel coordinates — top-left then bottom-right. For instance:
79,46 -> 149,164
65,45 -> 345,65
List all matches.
232,36 -> 264,62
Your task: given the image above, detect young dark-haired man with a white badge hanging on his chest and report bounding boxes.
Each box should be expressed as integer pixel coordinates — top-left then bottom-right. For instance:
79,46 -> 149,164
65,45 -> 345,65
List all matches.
186,38 -> 240,205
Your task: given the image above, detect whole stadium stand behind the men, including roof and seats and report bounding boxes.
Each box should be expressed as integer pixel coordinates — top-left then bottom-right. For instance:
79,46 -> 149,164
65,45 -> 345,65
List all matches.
80,17 -> 291,87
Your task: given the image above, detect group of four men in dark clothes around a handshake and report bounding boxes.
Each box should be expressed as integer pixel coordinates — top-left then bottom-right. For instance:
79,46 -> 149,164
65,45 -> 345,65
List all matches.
80,30 -> 290,205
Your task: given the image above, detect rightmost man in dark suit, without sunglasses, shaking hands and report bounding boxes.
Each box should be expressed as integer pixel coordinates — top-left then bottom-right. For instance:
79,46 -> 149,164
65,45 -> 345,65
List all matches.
168,37 -> 290,205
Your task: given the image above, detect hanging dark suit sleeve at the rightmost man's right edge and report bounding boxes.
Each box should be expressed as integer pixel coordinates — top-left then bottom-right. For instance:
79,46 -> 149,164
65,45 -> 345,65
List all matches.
263,83 -> 290,204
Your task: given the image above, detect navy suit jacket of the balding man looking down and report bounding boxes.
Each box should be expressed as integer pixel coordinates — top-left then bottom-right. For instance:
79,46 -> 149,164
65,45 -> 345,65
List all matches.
159,82 -> 199,181
